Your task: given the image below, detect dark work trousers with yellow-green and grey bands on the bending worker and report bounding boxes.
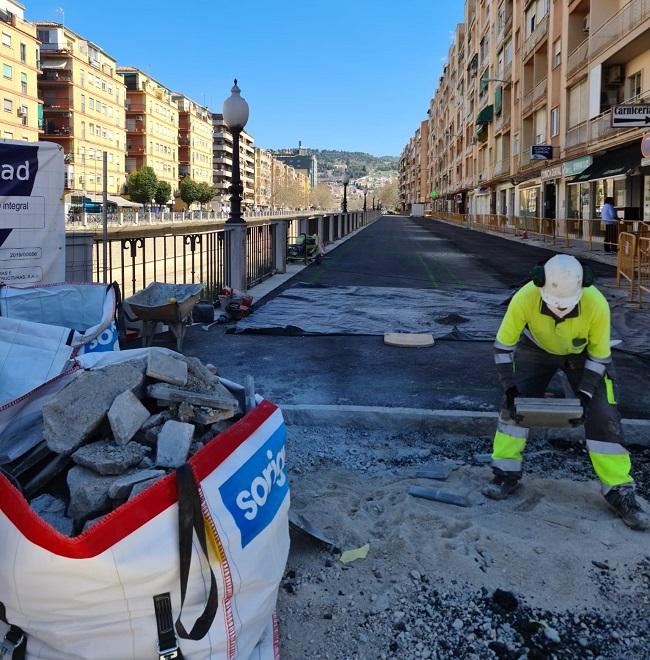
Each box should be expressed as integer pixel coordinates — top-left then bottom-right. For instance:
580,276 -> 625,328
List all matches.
492,338 -> 634,493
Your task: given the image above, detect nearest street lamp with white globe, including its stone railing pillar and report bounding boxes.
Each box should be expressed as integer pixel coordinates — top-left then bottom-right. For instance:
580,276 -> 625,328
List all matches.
223,78 -> 248,291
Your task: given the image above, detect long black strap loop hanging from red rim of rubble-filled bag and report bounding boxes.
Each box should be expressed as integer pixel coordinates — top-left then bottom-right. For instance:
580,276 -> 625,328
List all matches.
176,463 -> 219,641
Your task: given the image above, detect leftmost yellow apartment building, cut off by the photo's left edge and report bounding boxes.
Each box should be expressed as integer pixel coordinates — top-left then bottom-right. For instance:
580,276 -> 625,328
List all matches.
0,0 -> 43,142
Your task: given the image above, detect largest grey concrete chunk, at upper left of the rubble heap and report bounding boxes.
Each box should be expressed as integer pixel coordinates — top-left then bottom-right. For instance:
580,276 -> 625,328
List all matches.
43,360 -> 144,454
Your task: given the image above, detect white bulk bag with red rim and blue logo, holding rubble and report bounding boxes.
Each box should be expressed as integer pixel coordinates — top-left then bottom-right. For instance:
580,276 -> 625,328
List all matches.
0,366 -> 289,660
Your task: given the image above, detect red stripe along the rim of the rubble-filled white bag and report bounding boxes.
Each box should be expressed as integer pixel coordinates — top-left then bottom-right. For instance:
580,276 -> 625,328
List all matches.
0,401 -> 277,559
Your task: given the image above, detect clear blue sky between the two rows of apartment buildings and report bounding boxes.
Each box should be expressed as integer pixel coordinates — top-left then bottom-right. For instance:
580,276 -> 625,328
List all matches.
23,0 -> 463,156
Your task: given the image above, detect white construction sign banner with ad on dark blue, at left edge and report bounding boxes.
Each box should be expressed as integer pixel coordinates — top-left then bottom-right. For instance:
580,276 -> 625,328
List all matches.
0,140 -> 65,286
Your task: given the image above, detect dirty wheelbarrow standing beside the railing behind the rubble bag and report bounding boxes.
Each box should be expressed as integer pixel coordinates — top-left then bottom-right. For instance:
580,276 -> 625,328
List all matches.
124,282 -> 205,353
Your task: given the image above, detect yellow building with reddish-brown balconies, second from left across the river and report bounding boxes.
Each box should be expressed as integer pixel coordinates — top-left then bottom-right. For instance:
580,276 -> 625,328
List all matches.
36,22 -> 126,194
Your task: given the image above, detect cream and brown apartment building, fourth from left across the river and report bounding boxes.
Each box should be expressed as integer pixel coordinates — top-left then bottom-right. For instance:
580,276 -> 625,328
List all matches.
172,94 -> 212,185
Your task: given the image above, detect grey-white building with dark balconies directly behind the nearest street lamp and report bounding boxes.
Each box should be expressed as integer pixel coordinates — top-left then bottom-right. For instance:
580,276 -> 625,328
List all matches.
212,113 -> 255,209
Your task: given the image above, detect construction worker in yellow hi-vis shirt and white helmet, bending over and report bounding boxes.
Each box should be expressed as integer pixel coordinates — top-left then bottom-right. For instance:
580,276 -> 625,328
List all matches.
482,254 -> 650,530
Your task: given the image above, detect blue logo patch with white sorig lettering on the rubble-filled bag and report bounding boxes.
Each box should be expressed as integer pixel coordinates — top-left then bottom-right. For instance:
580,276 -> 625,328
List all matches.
219,424 -> 289,548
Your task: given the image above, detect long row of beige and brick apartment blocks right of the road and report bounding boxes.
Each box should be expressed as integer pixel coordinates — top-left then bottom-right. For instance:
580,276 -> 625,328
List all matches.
400,0 -> 650,219
